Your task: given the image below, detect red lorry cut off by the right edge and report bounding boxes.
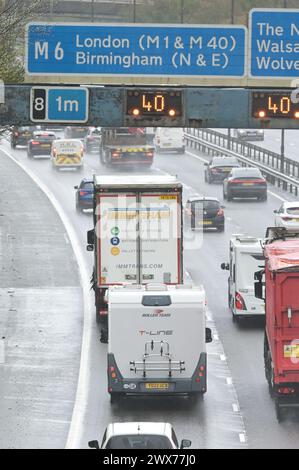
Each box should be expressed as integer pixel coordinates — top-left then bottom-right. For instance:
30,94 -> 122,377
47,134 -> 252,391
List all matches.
255,227 -> 299,421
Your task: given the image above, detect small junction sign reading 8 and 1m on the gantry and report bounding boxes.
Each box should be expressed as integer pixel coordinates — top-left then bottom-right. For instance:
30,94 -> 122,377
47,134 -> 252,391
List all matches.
30,86 -> 89,123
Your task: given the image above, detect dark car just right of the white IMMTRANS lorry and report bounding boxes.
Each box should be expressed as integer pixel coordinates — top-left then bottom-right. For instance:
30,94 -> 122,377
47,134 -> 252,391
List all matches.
184,196 -> 225,232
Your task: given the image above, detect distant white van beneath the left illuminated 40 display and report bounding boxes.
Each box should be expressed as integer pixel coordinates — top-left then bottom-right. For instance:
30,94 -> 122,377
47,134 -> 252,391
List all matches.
154,127 -> 185,153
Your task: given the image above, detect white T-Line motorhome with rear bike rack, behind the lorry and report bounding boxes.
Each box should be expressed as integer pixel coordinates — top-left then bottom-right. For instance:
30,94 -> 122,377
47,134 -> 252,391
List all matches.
107,284 -> 212,401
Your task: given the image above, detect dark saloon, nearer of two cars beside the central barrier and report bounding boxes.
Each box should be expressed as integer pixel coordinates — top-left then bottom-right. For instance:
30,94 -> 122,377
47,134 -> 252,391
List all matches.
223,167 -> 267,201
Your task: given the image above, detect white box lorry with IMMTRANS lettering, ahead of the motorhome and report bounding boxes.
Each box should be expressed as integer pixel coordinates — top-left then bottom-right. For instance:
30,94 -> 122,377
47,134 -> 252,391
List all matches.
87,174 -> 183,342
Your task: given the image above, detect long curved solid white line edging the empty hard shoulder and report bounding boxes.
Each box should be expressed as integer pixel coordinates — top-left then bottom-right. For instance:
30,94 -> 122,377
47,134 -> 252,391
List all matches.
1,148 -> 93,449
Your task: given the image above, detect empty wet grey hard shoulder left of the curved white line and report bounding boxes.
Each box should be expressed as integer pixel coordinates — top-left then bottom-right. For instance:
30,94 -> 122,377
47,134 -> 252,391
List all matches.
0,150 -> 83,448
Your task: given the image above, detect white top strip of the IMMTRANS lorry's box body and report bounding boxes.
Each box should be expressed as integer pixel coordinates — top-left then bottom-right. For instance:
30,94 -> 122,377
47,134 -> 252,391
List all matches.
94,174 -> 182,189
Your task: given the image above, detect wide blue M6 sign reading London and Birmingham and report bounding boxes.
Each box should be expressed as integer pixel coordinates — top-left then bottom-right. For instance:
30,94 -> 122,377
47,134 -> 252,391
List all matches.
26,23 -> 247,78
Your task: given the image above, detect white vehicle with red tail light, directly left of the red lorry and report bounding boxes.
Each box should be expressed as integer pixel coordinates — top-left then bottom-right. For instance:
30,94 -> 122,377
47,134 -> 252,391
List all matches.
221,235 -> 265,320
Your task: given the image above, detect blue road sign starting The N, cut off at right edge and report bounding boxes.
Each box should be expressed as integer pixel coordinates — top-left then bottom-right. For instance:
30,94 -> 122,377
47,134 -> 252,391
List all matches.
249,8 -> 299,78
